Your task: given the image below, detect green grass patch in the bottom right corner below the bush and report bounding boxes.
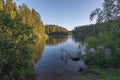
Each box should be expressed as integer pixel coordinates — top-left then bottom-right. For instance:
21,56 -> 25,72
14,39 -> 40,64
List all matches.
76,68 -> 120,80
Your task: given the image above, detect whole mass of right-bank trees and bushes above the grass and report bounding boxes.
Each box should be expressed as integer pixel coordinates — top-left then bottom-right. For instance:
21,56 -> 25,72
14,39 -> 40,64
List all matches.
72,0 -> 120,68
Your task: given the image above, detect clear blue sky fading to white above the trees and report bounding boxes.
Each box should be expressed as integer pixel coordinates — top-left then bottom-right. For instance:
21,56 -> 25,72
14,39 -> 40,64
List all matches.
16,0 -> 103,30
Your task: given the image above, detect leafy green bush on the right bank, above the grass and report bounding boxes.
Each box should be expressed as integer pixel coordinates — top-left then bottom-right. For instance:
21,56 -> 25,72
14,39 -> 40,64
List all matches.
85,28 -> 120,68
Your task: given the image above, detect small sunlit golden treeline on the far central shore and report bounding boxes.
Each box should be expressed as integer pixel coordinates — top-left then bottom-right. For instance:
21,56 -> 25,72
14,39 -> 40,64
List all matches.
45,25 -> 68,35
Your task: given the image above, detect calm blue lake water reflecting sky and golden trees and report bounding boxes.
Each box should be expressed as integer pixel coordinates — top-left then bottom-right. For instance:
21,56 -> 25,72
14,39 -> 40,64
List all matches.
34,36 -> 86,80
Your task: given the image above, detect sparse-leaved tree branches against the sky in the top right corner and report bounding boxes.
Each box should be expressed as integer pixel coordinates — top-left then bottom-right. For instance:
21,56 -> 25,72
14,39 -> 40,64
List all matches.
90,0 -> 120,23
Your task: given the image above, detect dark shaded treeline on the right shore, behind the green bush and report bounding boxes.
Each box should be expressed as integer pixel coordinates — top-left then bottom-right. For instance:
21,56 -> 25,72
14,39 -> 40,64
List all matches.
72,19 -> 120,40
